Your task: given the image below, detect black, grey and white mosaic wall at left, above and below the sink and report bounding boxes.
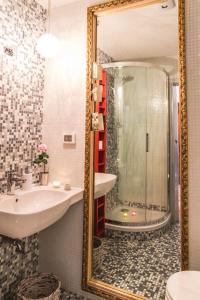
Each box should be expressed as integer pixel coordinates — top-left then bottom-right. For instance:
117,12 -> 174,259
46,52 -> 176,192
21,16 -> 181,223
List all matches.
0,0 -> 46,300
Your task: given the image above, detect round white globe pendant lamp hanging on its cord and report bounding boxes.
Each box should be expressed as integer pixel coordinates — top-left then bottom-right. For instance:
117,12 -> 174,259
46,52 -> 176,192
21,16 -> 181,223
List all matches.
36,0 -> 59,58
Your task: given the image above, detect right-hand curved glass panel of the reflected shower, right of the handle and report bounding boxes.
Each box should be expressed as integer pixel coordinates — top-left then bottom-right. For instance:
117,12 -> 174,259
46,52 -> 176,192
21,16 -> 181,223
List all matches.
147,68 -> 169,221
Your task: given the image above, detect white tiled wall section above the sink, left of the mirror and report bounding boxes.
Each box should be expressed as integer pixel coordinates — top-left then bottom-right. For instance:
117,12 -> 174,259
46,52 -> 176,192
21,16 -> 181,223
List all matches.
43,4 -> 86,186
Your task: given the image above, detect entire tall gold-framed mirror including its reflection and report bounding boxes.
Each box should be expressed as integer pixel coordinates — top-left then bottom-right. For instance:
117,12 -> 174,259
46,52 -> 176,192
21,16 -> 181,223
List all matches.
83,0 -> 188,300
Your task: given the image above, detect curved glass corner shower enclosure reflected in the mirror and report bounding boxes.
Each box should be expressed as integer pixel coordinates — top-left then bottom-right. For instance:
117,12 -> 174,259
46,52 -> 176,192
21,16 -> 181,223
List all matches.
104,62 -> 170,231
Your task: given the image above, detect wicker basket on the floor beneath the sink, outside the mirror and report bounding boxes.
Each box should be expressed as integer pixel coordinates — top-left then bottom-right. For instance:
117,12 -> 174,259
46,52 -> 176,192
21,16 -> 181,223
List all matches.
17,273 -> 61,300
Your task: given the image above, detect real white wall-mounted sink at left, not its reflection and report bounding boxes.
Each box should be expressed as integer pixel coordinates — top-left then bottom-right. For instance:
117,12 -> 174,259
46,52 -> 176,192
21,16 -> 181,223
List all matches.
0,186 -> 83,239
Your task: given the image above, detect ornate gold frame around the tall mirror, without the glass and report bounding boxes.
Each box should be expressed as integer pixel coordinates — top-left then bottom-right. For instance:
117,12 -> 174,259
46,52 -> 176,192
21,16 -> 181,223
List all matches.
82,0 -> 189,300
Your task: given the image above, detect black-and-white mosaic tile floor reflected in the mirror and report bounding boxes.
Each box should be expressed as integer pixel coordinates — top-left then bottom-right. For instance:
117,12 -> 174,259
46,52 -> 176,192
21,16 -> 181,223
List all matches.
93,225 -> 180,300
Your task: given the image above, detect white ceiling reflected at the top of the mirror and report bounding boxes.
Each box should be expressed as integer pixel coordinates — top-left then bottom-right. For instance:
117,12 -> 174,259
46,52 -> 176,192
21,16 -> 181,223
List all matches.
97,4 -> 178,61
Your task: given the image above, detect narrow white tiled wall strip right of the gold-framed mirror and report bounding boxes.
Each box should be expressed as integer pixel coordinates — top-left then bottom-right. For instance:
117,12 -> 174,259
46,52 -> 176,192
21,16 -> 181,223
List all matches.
186,0 -> 200,270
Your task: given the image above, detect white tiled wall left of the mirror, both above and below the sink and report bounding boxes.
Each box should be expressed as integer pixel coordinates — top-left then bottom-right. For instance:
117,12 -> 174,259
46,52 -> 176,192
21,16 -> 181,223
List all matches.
39,0 -> 104,300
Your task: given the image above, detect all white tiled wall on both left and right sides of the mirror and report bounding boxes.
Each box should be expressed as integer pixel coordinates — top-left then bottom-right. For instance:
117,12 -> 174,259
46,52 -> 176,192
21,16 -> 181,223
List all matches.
40,0 -> 200,299
